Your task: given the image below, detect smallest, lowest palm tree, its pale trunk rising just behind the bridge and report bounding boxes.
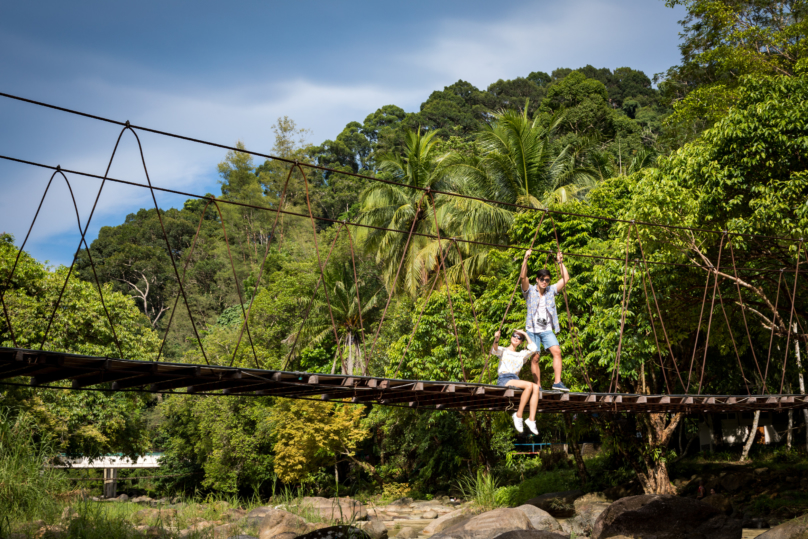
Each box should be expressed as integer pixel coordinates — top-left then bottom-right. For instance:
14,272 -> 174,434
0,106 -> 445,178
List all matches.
284,264 -> 381,376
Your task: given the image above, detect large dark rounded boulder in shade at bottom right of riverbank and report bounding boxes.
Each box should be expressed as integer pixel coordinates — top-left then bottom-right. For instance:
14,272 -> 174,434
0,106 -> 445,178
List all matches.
592,494 -> 742,539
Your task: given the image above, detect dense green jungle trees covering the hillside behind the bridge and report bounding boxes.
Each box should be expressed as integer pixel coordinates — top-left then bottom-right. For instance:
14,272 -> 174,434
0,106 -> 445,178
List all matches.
0,0 -> 808,498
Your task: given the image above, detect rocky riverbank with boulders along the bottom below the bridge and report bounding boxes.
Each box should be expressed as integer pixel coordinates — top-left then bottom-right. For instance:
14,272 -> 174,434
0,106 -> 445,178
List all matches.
25,491 -> 808,539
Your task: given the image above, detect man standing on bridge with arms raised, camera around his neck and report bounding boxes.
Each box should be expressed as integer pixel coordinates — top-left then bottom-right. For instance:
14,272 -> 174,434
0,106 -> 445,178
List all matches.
519,249 -> 570,392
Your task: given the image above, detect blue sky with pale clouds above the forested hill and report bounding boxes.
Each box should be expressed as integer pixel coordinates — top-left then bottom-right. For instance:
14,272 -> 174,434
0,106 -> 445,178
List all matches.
0,0 -> 684,263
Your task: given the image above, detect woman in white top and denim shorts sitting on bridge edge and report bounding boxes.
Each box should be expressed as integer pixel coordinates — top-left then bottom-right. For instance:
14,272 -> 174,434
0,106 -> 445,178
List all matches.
491,329 -> 541,434
